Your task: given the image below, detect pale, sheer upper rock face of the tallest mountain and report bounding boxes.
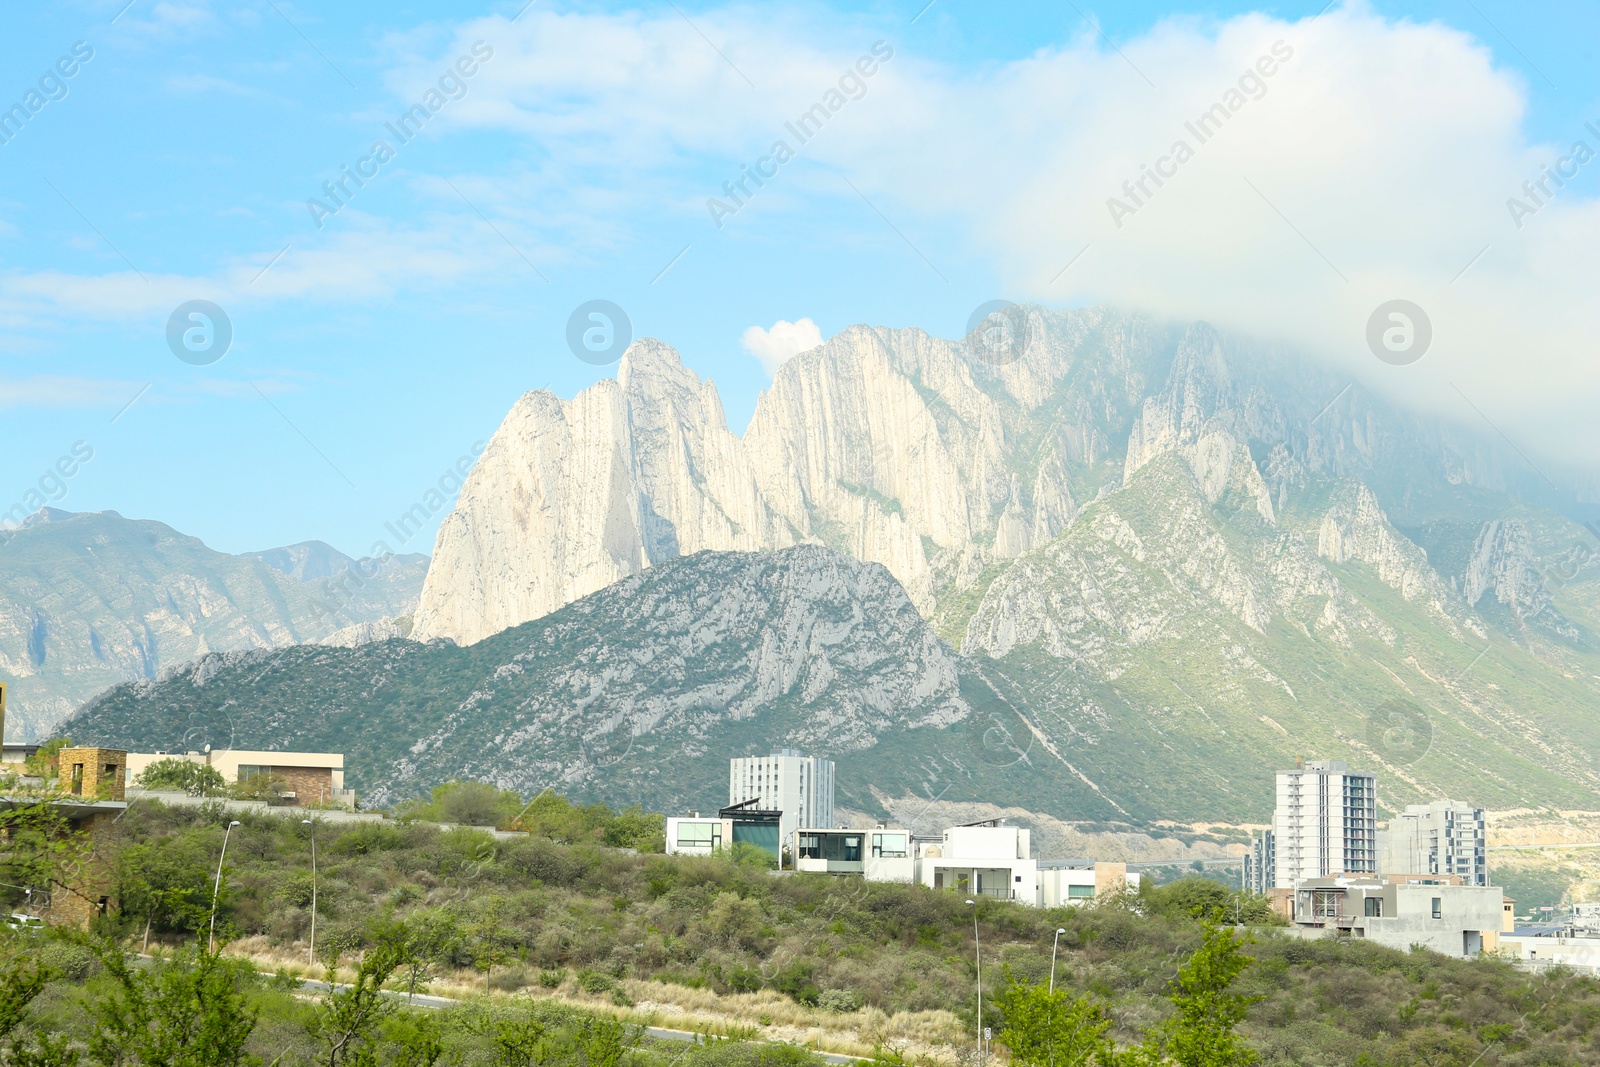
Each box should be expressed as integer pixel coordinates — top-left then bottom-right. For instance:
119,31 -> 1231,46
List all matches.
416,309 -> 1561,643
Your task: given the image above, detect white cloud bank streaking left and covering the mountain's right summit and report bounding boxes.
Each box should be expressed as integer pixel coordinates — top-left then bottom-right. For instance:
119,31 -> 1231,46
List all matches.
18,0 -> 1600,466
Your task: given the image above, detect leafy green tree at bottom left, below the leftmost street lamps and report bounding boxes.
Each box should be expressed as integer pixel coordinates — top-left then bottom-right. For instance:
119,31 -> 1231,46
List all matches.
82,937 -> 256,1067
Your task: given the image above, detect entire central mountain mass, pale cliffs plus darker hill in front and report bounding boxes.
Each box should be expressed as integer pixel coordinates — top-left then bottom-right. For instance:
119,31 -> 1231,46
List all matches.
56,309 -> 1600,822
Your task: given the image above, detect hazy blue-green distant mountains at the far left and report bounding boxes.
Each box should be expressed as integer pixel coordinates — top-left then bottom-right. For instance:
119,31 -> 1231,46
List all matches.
0,509 -> 427,741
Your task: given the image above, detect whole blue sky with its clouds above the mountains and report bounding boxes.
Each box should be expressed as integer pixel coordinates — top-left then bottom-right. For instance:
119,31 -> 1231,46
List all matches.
0,0 -> 1600,553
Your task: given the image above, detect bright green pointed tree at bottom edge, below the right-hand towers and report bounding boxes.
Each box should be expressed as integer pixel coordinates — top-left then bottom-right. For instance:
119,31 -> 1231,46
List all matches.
1155,923 -> 1262,1067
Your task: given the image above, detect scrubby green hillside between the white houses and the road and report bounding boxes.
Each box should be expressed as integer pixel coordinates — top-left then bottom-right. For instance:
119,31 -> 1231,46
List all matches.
3,793 -> 1600,1067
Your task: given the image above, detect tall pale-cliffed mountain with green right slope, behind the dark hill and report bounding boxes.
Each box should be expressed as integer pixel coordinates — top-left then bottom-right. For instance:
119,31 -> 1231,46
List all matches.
387,307 -> 1600,817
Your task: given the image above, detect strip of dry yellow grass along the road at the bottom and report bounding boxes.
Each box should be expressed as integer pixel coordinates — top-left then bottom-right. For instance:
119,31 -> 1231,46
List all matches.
224,936 -> 971,1062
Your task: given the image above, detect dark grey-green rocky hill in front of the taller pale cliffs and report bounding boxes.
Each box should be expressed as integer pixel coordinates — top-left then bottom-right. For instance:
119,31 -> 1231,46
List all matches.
64,545 -> 1043,811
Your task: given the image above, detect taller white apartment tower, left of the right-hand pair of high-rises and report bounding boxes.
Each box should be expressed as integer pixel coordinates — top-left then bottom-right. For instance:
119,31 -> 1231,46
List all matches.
1272,760 -> 1378,889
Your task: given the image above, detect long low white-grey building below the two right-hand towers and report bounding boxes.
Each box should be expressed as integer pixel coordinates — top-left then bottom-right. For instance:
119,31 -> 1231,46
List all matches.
1293,875 -> 1509,957
